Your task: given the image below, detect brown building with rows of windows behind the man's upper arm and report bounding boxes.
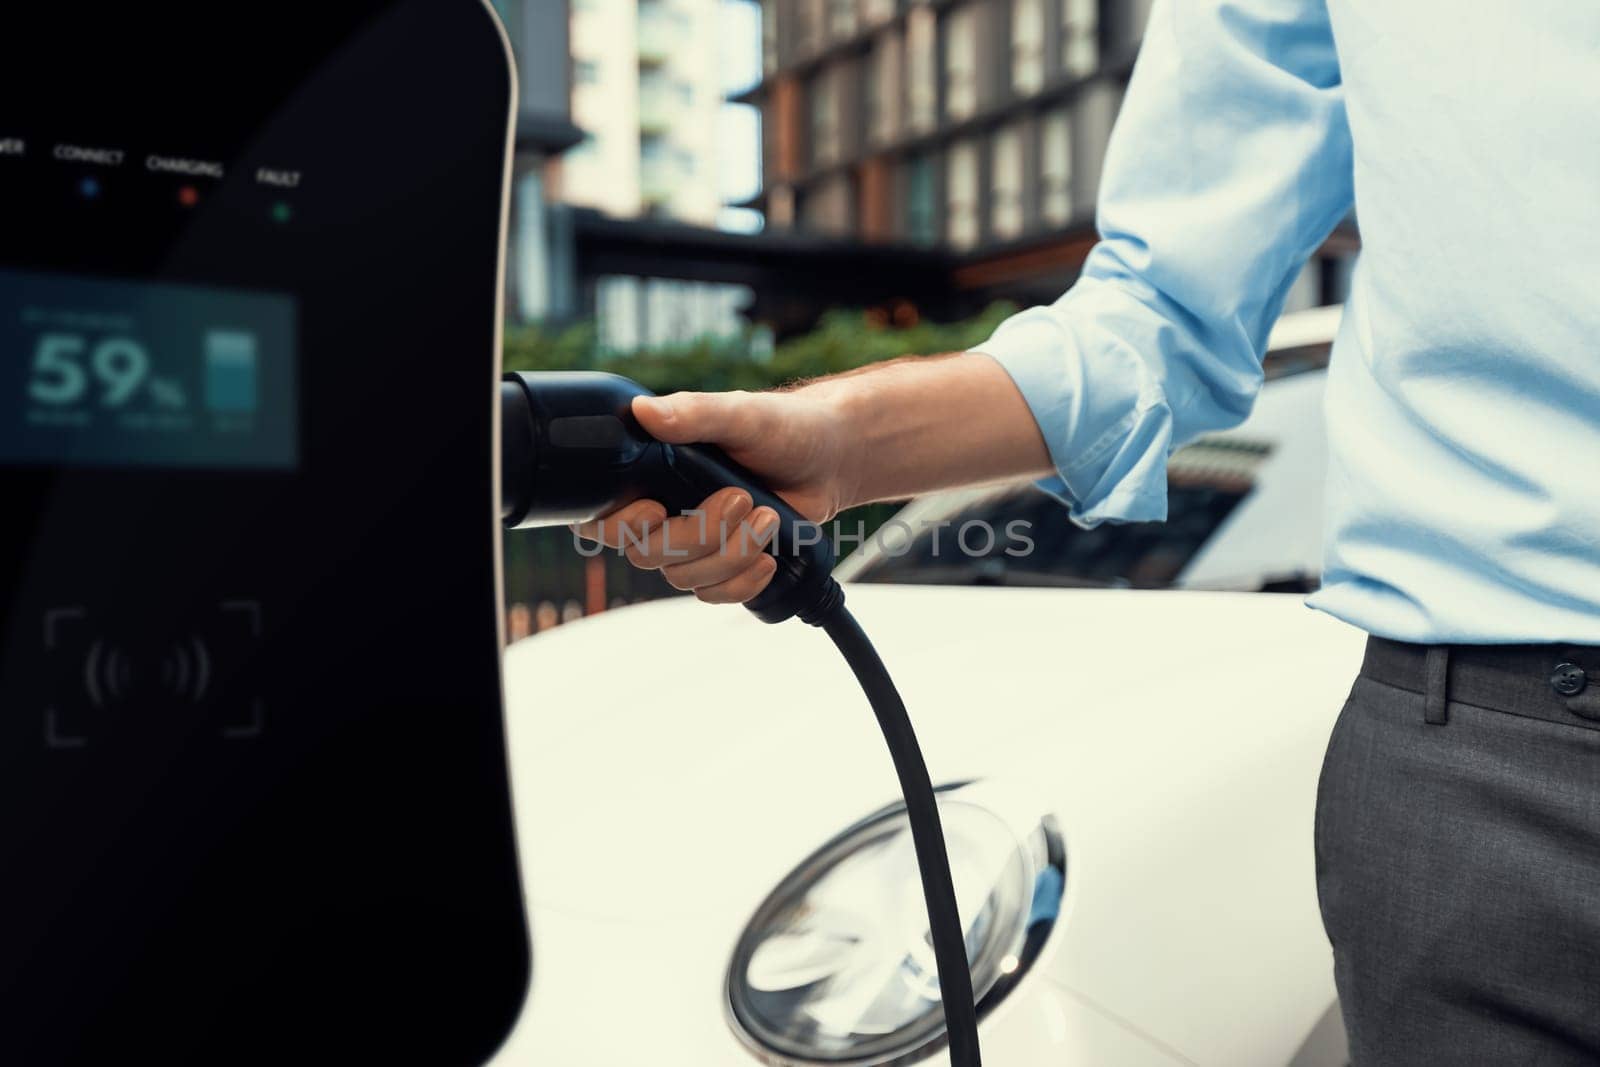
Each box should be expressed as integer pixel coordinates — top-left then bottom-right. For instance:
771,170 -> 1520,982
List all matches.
739,0 -> 1355,309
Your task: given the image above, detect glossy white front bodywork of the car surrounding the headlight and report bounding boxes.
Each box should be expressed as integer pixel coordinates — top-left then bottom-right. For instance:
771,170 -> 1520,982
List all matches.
506,585 -> 1362,1064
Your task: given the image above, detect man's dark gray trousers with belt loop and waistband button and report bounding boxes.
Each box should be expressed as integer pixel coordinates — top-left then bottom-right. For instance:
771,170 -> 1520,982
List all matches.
1315,638 -> 1600,1067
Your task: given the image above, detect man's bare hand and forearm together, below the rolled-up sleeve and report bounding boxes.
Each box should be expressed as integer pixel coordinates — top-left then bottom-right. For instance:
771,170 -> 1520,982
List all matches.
578,355 -> 1051,603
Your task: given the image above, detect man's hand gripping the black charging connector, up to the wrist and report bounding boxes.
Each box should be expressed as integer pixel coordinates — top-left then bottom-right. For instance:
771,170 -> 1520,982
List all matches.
578,387 -> 853,603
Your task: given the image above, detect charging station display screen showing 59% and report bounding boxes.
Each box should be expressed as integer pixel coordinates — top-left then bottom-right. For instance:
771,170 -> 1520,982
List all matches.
0,270 -> 299,469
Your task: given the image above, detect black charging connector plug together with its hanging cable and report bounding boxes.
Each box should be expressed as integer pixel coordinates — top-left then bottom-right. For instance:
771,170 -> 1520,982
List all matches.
501,371 -> 979,1067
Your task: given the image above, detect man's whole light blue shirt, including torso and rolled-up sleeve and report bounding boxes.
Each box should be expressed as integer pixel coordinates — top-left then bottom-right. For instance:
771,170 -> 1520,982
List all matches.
979,0 -> 1600,645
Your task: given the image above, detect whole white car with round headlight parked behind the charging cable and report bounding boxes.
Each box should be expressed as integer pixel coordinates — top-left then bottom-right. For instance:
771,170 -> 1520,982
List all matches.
499,309 -> 1363,1067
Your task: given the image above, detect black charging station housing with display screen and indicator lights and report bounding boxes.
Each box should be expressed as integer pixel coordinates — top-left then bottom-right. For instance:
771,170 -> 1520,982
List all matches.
0,0 -> 531,1065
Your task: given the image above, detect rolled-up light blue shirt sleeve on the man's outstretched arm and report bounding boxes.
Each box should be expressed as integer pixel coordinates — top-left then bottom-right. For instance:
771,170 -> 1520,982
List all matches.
974,0 -> 1352,526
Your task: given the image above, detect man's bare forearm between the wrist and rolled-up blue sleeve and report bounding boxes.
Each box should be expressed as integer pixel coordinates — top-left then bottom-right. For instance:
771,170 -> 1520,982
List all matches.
808,354 -> 1053,504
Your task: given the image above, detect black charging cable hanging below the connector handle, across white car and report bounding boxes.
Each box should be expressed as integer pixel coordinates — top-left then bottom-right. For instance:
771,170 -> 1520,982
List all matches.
806,598 -> 981,1067
